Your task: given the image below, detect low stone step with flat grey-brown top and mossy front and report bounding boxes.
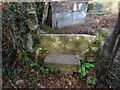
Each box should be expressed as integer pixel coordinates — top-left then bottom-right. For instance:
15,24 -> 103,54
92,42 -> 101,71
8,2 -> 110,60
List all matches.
44,53 -> 80,74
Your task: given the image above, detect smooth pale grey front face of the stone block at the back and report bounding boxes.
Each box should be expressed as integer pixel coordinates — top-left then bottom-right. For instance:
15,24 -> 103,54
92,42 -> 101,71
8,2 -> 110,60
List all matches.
53,12 -> 85,28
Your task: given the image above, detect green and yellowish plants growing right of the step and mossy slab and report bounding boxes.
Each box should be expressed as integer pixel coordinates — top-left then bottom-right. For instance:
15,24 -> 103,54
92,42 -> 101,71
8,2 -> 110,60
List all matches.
79,31 -> 105,86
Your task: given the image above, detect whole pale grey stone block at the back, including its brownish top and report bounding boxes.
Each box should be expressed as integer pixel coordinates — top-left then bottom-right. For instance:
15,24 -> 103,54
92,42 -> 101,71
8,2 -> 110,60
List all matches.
52,2 -> 87,28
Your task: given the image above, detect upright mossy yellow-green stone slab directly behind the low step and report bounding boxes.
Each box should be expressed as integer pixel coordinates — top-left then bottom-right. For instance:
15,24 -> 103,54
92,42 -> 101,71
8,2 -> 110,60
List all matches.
40,34 -> 96,55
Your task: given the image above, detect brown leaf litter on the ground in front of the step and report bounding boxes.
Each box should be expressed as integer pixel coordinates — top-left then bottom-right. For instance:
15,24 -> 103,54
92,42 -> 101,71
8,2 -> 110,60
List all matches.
3,74 -> 108,88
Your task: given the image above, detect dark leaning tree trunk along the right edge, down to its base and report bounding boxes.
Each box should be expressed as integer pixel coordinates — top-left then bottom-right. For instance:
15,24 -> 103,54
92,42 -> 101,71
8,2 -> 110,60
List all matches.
96,4 -> 120,87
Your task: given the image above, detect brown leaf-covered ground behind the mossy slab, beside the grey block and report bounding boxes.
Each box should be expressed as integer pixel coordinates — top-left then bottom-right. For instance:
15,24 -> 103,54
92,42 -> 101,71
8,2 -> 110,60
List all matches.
50,13 -> 117,34
